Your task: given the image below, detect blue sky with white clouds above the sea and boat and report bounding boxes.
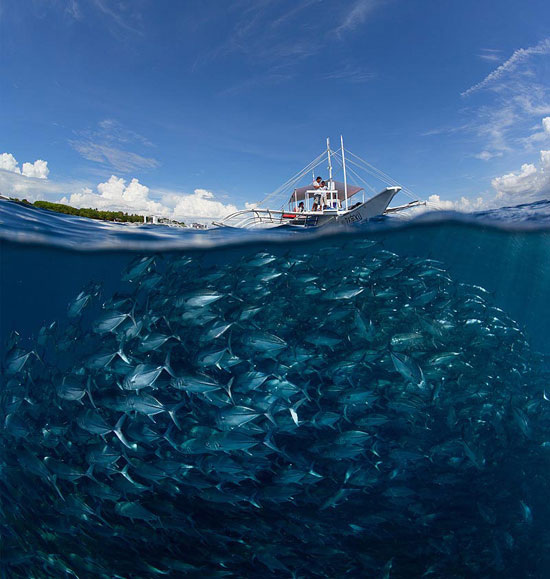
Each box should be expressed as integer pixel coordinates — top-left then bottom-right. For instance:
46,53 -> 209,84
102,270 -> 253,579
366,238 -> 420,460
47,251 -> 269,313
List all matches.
0,0 -> 550,220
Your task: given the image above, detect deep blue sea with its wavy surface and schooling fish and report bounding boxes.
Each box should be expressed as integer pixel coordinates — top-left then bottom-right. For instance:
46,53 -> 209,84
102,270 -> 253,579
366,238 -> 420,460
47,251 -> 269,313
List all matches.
0,201 -> 550,578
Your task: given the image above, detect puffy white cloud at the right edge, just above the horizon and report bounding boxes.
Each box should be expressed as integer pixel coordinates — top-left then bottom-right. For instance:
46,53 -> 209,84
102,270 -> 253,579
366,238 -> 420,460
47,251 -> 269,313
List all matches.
491,151 -> 550,203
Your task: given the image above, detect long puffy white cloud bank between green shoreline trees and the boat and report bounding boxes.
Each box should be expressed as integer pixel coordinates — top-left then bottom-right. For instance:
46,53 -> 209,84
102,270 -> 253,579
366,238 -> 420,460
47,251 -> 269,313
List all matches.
60,175 -> 237,221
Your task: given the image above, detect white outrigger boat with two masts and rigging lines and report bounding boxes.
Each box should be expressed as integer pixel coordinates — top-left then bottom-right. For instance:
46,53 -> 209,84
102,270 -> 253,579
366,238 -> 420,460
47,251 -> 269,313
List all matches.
213,137 -> 425,229
